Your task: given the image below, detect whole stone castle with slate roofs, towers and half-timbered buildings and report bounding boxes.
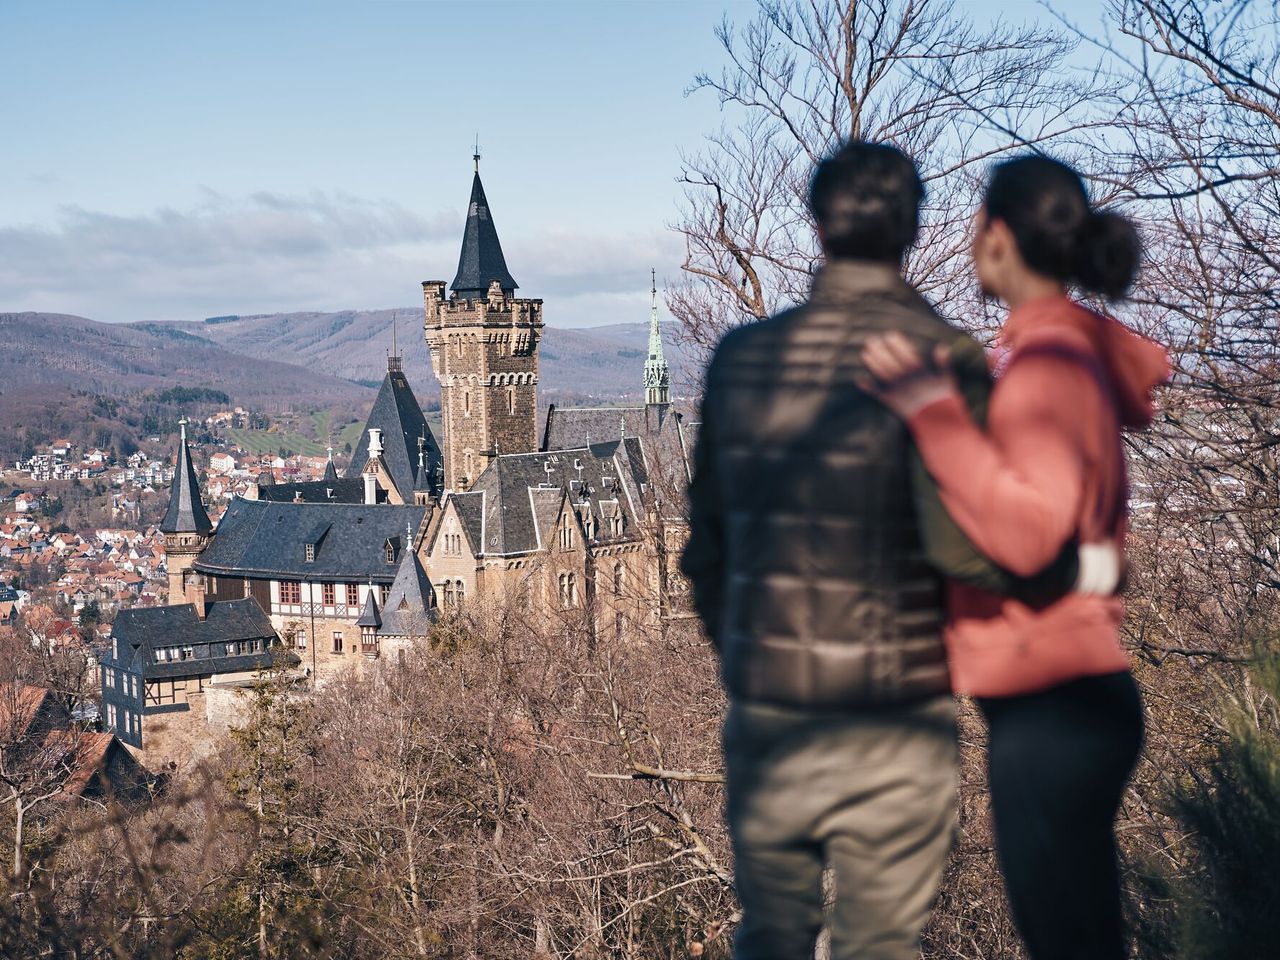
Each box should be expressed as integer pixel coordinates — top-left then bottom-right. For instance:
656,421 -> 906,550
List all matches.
101,156 -> 696,763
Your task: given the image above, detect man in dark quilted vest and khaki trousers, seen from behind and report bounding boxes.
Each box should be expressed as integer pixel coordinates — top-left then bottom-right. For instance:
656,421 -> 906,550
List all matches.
681,142 -> 989,960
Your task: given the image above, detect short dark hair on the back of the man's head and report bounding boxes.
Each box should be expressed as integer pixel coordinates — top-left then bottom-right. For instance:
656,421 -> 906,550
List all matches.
809,141 -> 924,264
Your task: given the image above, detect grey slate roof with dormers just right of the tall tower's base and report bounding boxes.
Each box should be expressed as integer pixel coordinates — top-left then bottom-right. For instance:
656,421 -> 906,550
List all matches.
454,438 -> 648,556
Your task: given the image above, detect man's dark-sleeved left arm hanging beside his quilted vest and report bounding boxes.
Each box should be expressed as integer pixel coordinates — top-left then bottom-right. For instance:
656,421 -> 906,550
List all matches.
680,358 -> 724,648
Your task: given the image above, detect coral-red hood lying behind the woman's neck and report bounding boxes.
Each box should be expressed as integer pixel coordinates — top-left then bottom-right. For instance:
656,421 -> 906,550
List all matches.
1001,297 -> 1171,430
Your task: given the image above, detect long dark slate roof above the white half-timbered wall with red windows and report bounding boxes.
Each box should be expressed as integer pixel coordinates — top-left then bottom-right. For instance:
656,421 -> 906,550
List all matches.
195,497 -> 426,584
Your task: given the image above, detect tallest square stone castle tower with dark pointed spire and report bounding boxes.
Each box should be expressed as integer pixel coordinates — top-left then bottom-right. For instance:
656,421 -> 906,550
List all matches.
422,155 -> 543,492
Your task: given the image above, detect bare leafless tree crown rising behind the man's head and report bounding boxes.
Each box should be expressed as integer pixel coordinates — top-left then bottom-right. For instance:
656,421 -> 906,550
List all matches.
668,0 -> 1102,366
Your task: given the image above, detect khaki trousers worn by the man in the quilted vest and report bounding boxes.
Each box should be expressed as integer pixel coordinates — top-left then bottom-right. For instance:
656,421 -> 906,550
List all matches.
724,696 -> 956,960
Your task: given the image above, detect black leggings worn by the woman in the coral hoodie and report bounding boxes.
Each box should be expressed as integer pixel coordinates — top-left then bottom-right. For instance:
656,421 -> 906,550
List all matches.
979,672 -> 1142,960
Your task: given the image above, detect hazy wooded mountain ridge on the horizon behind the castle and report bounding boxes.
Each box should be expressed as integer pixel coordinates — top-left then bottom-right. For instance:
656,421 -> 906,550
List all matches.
0,308 -> 689,415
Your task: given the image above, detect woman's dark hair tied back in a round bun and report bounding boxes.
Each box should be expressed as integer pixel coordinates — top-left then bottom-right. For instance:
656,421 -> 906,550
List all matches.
983,156 -> 1142,300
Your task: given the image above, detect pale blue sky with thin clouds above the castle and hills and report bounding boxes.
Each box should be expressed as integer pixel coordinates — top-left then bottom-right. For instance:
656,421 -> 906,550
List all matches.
0,0 -> 1094,326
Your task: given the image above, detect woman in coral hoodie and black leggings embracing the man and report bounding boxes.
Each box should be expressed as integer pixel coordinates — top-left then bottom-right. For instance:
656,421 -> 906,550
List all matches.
863,156 -> 1169,960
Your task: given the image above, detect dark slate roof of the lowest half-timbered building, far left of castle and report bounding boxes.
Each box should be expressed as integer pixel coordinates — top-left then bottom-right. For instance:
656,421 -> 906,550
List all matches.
101,596 -> 279,680
